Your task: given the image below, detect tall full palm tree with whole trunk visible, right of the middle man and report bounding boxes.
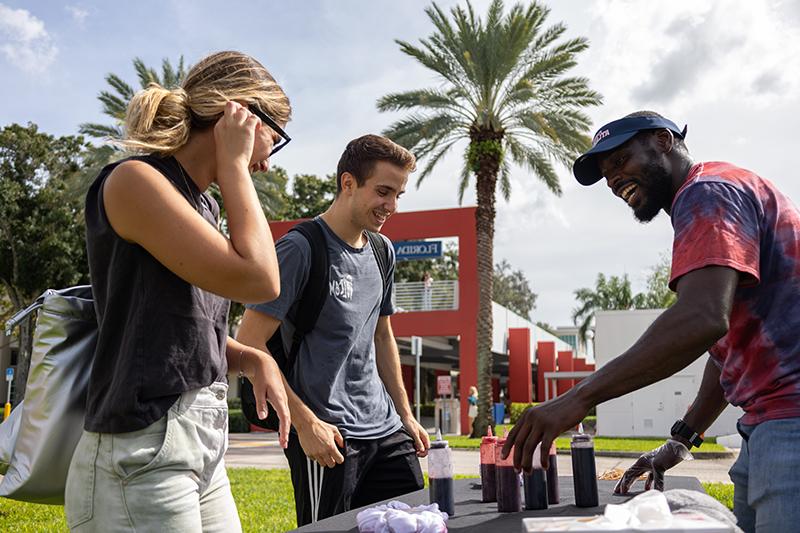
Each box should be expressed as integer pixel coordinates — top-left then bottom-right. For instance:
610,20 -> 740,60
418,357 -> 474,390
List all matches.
378,0 -> 601,435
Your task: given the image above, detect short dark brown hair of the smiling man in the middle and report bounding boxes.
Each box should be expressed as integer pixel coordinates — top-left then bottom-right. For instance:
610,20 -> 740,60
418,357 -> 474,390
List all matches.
336,134 -> 417,196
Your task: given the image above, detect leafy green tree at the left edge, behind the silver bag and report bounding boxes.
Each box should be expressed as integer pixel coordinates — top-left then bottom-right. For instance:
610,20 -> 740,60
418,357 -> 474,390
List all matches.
0,124 -> 88,309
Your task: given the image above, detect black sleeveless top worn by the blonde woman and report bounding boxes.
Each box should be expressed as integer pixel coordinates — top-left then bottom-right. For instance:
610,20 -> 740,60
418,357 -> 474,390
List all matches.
84,155 -> 230,433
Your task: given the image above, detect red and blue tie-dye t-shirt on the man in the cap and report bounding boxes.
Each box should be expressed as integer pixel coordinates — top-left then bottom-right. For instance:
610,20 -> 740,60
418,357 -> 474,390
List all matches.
670,162 -> 800,424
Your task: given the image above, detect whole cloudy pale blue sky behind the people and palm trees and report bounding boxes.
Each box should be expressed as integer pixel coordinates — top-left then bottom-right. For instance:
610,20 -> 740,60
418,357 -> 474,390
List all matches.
0,0 -> 800,326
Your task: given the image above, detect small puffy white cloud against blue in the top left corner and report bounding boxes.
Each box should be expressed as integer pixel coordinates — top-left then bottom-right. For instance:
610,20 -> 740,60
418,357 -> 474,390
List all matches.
0,4 -> 58,73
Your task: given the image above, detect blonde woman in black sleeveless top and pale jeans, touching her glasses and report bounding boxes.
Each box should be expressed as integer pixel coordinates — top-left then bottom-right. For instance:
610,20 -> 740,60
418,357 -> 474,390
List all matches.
66,52 -> 291,532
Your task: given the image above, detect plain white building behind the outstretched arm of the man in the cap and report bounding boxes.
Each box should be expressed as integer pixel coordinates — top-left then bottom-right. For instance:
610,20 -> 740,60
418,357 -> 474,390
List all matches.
594,309 -> 743,437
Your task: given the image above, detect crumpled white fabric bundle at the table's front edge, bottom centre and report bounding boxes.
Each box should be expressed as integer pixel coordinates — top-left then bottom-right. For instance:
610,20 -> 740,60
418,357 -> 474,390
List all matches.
356,500 -> 448,533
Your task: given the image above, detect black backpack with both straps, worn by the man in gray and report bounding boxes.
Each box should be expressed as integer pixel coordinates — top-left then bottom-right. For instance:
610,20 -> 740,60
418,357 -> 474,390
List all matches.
239,220 -> 390,430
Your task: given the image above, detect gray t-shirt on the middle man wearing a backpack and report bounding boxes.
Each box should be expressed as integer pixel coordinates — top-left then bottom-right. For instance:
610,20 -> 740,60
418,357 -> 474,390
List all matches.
247,217 -> 402,439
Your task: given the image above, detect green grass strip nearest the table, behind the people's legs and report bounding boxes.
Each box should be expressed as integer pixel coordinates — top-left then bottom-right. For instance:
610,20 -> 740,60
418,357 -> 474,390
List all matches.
0,468 -> 733,533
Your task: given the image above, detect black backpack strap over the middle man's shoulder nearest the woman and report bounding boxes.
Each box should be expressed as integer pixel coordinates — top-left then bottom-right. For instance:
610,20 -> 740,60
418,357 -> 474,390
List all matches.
286,220 -> 328,370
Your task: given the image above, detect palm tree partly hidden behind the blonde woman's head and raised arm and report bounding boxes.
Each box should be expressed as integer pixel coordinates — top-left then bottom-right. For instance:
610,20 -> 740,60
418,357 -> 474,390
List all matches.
75,56 -> 286,217
